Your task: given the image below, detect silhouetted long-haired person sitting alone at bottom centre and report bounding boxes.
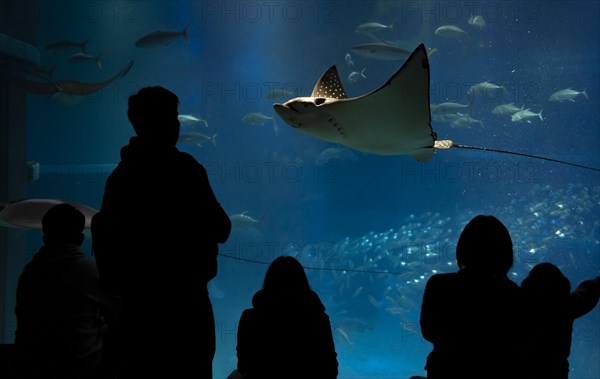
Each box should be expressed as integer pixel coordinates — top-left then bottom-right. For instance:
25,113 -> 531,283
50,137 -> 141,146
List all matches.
229,256 -> 338,379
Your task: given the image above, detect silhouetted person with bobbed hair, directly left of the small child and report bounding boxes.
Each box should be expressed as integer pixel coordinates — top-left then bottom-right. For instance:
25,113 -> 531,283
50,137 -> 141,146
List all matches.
420,215 -> 520,379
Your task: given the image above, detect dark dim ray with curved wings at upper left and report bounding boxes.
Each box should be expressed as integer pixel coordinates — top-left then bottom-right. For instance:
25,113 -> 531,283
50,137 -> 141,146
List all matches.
9,61 -> 133,105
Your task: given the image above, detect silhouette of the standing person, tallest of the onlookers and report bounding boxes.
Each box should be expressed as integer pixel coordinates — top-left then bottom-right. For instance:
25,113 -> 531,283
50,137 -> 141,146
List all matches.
92,87 -> 231,379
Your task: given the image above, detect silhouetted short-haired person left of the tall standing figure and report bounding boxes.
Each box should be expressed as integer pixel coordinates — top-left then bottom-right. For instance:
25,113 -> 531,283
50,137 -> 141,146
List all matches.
15,203 -> 116,379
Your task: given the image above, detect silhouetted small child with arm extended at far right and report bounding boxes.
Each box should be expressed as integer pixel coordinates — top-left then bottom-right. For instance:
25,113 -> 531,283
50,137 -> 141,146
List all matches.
521,262 -> 600,379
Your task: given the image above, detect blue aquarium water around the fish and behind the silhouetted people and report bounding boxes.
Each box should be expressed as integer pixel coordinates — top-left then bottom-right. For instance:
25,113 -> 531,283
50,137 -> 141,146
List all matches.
5,0 -> 600,378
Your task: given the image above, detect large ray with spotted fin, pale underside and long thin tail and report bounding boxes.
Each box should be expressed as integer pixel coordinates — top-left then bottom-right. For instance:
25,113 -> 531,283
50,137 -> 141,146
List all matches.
273,44 -> 600,171
